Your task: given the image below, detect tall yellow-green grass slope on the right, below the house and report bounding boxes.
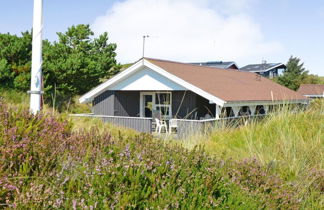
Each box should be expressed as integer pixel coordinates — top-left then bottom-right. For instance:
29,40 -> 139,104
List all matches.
178,100 -> 324,208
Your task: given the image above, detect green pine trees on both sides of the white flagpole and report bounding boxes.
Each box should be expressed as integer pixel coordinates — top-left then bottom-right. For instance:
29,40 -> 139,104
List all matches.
0,24 -> 121,108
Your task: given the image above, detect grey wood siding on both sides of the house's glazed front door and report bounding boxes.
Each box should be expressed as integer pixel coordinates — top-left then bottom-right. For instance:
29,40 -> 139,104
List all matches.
93,91 -> 215,119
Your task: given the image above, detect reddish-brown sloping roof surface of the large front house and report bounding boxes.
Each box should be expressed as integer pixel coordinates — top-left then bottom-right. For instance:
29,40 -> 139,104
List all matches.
145,58 -> 307,102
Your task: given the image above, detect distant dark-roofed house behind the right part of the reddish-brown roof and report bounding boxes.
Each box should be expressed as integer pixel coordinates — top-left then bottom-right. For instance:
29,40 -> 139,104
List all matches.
240,63 -> 286,79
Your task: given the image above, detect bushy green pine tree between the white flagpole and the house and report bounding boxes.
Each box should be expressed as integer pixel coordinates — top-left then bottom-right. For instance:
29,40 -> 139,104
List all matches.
43,24 -> 121,101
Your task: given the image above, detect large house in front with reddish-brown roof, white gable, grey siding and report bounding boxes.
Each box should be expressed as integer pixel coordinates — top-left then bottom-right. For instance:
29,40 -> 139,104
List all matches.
80,58 -> 309,132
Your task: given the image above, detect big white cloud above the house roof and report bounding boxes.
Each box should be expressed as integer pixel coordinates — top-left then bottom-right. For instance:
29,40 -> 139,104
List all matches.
92,0 -> 282,63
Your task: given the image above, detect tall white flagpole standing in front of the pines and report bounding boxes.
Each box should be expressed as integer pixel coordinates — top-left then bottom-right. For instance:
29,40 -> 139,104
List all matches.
29,0 -> 43,114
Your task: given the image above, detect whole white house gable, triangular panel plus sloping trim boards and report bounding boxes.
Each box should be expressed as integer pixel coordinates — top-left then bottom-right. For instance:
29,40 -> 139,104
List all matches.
79,59 -> 225,106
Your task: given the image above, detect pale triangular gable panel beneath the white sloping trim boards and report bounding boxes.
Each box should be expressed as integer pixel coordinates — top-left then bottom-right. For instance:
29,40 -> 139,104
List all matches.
109,68 -> 186,91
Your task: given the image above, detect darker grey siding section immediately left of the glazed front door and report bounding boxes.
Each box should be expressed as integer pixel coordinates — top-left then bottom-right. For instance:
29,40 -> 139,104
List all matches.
114,91 -> 140,117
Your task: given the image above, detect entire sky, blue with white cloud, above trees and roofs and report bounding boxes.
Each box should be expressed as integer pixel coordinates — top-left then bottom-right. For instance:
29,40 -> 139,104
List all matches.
0,0 -> 324,76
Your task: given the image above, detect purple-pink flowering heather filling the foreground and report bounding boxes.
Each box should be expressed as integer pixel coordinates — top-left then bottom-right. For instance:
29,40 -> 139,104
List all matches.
0,102 -> 314,209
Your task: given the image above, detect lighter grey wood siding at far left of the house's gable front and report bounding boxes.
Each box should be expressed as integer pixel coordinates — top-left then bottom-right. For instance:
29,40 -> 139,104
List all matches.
92,90 -> 115,116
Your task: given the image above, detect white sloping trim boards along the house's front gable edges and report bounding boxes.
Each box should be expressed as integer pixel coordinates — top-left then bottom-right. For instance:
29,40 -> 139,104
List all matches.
79,59 -> 226,106
